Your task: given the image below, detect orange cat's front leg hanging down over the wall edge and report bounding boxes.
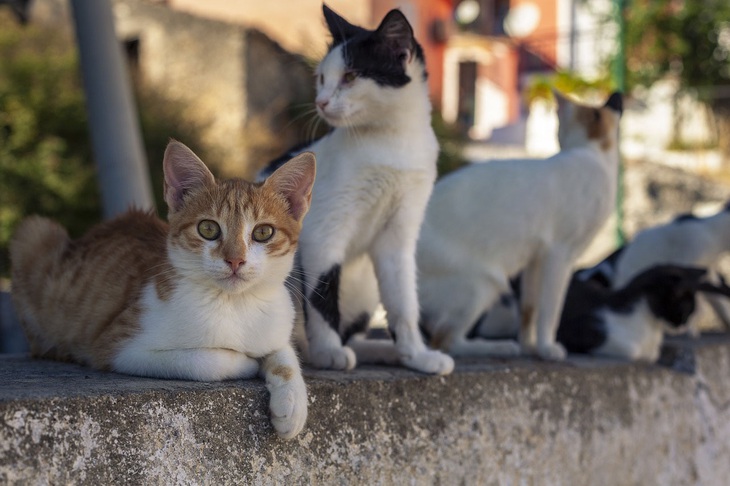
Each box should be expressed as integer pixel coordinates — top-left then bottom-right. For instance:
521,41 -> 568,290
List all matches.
261,346 -> 307,439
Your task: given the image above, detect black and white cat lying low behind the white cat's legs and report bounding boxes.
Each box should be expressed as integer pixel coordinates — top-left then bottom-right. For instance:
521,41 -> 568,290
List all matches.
470,265 -> 730,362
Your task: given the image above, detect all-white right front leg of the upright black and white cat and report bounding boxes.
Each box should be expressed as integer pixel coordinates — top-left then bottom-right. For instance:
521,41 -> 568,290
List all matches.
372,220 -> 454,375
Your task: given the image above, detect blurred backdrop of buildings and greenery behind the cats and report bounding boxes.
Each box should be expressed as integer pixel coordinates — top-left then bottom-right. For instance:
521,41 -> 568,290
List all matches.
0,0 -> 730,350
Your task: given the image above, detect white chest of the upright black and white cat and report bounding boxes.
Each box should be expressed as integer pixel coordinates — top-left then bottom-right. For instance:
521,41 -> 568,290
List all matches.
300,126 -> 438,256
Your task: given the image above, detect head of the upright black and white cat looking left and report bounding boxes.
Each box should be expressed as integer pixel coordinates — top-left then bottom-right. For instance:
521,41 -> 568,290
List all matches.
315,5 -> 425,127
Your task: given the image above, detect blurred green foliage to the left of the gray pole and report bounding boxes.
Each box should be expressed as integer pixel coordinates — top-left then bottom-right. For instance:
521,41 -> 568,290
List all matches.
0,15 -> 100,274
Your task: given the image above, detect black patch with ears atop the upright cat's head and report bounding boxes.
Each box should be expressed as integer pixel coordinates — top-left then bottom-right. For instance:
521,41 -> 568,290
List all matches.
324,7 -> 425,88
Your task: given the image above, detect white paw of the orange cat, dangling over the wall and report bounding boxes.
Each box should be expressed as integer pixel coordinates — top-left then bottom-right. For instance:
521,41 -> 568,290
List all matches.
269,379 -> 307,439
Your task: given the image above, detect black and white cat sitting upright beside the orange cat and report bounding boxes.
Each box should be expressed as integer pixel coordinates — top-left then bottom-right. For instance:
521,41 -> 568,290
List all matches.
258,5 -> 454,374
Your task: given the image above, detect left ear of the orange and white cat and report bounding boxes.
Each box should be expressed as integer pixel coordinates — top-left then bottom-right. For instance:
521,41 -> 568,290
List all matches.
162,140 -> 215,211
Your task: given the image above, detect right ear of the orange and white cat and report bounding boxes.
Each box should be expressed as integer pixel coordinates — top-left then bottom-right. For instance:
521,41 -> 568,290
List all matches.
264,152 -> 317,222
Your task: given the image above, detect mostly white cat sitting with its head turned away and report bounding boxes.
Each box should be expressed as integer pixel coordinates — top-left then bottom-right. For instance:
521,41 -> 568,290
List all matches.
417,93 -> 622,359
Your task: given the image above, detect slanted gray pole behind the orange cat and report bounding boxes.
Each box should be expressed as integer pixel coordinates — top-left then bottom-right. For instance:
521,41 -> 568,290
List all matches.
71,0 -> 154,218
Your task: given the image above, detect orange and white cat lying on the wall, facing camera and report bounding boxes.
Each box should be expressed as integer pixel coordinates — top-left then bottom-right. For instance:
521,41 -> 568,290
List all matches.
10,141 -> 315,438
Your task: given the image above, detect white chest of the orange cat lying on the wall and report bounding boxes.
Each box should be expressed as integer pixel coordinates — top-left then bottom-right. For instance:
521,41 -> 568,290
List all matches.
135,282 -> 294,358
